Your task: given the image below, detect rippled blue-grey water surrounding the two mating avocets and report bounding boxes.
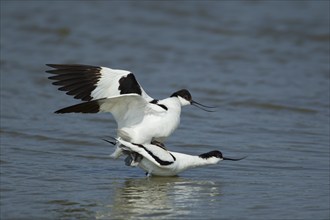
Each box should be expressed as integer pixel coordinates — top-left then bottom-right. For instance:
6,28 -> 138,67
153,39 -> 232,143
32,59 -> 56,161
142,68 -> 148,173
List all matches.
0,1 -> 330,219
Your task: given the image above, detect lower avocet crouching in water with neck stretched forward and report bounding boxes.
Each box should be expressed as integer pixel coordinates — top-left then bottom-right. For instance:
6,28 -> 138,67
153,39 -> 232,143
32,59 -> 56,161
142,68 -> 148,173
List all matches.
105,138 -> 244,176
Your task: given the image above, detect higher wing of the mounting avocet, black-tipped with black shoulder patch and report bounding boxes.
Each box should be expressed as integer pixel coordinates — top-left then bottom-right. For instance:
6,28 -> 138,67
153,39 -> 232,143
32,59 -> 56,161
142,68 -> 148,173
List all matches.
46,64 -> 153,102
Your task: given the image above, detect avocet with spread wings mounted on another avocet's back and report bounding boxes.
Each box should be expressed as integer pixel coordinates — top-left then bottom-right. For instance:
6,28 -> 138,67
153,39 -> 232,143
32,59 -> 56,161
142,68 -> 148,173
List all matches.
46,64 -> 212,144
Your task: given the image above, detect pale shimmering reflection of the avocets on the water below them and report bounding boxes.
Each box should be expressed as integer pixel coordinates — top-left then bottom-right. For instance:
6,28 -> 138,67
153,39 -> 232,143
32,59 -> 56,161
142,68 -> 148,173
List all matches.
97,177 -> 221,219
